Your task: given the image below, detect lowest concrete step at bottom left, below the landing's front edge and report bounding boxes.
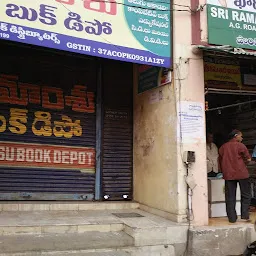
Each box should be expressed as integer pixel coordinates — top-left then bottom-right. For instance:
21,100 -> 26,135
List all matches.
0,231 -> 134,256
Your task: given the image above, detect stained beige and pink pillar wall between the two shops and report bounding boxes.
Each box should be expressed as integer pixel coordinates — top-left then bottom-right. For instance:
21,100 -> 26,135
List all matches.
134,0 -> 208,226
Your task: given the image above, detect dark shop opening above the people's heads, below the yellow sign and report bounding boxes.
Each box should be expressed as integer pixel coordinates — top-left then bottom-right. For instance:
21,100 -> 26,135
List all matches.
206,90 -> 256,150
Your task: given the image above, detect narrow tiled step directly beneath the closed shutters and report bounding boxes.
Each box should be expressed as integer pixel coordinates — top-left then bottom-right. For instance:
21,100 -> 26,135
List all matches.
0,201 -> 139,212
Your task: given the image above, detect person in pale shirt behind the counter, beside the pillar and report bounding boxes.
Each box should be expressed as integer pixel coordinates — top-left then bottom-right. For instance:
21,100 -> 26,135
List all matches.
206,132 -> 219,177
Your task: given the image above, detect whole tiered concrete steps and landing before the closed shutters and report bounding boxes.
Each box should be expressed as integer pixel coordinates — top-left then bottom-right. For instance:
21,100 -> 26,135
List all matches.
0,209 -> 187,256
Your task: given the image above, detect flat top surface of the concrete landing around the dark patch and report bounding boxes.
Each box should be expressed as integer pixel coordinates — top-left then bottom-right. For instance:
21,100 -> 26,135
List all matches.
0,209 -> 184,228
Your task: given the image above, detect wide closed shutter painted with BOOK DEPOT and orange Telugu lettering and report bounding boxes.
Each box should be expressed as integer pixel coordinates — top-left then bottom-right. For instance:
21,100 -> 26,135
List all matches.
0,43 -> 97,200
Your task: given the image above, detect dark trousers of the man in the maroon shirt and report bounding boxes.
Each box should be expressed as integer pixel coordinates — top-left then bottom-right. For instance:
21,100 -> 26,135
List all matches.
225,179 -> 251,222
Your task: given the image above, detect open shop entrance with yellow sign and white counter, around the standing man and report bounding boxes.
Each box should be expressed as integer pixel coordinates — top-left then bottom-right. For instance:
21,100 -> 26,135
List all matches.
204,49 -> 256,220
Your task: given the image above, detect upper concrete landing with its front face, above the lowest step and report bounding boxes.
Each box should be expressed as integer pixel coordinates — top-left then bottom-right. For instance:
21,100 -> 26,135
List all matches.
0,209 -> 188,256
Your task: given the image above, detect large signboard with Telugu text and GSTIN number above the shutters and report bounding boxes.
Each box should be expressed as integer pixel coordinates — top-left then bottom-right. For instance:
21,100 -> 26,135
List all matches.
0,0 -> 172,67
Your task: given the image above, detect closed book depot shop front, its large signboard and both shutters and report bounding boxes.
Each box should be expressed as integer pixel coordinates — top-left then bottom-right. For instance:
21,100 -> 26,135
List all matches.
0,0 -> 171,201
